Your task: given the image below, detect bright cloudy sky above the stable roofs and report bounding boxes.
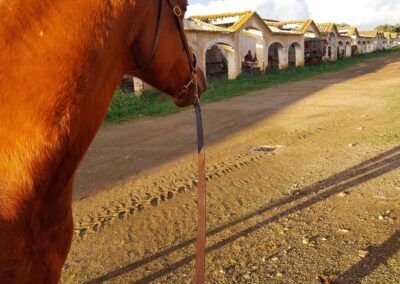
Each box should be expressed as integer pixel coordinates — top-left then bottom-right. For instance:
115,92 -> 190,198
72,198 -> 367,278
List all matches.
187,0 -> 400,30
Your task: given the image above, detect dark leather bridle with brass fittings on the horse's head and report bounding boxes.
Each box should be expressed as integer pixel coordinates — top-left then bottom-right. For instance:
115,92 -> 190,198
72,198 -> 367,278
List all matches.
134,0 -> 199,104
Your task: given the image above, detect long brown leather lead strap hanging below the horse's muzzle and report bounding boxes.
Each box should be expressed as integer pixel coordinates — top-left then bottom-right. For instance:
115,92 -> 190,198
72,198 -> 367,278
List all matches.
194,102 -> 206,284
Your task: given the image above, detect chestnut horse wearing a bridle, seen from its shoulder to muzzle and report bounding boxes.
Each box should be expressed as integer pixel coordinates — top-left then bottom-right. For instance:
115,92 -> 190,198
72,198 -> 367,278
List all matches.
0,0 -> 205,283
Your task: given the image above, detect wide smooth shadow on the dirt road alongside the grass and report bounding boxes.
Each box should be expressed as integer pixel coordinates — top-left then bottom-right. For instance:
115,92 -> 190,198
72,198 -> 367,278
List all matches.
74,53 -> 400,200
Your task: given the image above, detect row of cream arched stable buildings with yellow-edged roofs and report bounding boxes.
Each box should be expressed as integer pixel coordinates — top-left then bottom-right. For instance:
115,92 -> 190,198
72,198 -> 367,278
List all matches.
121,11 -> 400,94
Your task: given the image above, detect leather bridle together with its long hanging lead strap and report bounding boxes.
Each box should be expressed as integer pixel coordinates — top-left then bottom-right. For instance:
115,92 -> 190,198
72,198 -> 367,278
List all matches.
135,0 -> 206,284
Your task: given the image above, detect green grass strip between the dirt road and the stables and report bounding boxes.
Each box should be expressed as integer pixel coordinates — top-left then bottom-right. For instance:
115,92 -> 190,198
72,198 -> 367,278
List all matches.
106,48 -> 400,122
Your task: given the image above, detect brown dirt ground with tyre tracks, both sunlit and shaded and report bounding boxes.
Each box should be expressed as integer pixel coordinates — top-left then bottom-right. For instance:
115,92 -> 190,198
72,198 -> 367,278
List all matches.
62,53 -> 400,284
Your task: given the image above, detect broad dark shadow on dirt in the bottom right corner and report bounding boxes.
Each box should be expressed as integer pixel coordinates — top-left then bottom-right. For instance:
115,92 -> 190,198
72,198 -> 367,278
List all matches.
335,230 -> 400,284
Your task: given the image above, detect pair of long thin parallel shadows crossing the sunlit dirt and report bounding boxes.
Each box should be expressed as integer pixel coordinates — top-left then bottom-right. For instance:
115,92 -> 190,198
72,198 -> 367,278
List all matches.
85,147 -> 400,284
